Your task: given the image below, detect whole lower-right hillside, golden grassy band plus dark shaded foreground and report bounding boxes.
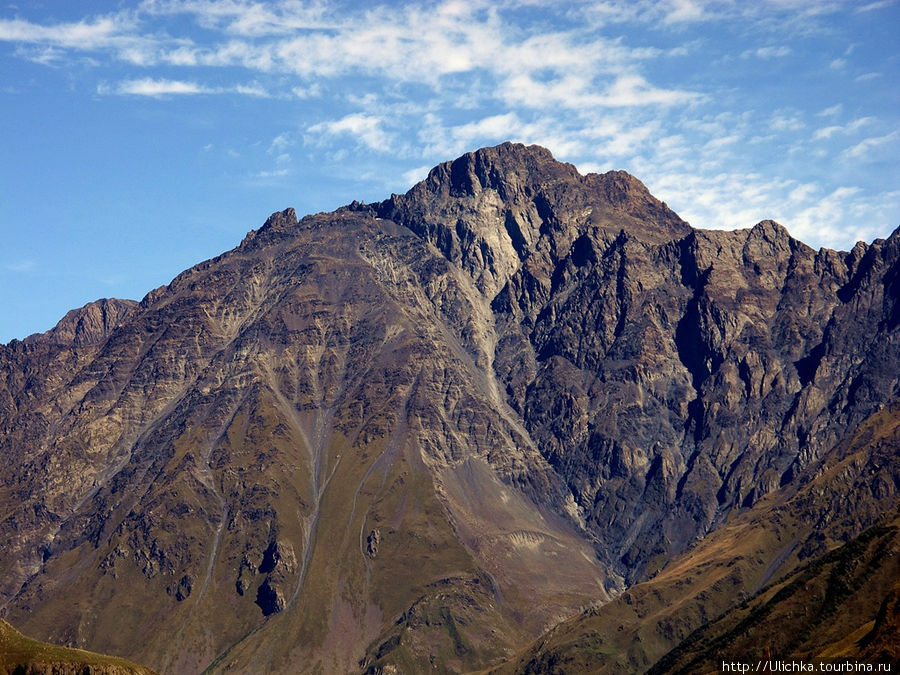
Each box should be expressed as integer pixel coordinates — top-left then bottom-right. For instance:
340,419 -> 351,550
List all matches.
496,402 -> 900,673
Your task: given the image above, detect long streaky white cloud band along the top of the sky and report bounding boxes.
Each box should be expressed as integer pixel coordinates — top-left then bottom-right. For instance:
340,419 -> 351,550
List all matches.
0,0 -> 699,107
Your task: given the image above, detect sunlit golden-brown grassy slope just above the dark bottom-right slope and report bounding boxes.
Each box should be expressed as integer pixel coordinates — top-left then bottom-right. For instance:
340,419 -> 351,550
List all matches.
492,404 -> 900,673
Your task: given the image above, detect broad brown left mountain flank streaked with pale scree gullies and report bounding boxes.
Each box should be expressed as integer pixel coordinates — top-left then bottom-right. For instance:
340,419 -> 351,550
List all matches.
0,193 -> 614,672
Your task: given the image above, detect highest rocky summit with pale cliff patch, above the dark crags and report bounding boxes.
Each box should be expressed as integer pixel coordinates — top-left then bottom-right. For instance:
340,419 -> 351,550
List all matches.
376,142 -> 690,297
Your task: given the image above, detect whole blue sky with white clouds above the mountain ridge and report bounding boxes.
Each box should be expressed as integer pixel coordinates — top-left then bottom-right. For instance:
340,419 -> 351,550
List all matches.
0,0 -> 900,342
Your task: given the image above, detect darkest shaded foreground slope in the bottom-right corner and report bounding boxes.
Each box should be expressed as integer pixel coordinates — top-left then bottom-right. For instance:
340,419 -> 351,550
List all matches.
650,517 -> 900,673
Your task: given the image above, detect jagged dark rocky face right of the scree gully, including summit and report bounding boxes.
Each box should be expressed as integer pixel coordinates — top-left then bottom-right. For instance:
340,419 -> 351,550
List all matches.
378,145 -> 900,582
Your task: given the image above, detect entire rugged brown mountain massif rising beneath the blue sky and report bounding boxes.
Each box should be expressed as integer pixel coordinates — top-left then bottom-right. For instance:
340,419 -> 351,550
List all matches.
0,143 -> 900,673
